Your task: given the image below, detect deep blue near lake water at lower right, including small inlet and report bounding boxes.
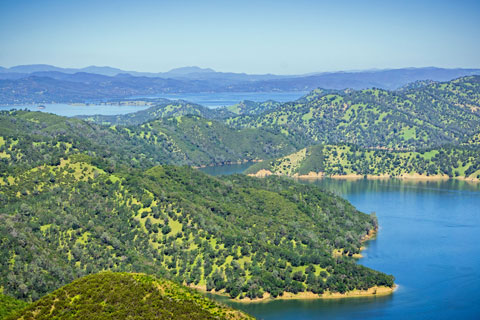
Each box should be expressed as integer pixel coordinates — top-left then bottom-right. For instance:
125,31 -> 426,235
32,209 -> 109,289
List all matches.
197,165 -> 480,319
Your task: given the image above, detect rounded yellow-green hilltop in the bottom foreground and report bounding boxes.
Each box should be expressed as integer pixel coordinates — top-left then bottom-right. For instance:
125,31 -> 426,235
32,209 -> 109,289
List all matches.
7,272 -> 253,320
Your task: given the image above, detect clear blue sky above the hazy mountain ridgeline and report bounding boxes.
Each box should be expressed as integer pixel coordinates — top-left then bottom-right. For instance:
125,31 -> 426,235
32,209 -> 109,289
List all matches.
0,0 -> 480,74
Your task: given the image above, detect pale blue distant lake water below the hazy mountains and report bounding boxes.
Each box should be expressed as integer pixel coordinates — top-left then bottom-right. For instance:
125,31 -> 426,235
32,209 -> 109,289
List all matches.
0,91 -> 306,117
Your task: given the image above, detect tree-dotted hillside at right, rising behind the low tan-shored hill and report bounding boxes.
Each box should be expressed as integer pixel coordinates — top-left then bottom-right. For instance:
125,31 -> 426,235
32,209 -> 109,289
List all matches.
226,76 -> 480,150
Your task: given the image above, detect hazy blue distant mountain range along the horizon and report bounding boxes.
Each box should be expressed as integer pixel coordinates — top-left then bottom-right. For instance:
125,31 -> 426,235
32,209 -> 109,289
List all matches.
0,65 -> 480,104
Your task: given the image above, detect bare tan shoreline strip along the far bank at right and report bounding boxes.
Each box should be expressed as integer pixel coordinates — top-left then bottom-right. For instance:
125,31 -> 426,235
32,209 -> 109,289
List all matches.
248,169 -> 480,182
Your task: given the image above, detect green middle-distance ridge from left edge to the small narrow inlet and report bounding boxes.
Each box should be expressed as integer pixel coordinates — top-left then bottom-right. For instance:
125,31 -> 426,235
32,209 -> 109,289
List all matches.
0,111 -> 297,171
